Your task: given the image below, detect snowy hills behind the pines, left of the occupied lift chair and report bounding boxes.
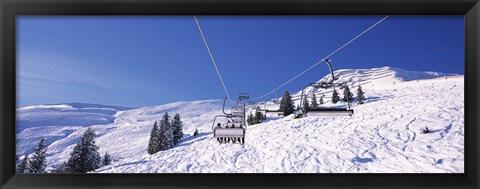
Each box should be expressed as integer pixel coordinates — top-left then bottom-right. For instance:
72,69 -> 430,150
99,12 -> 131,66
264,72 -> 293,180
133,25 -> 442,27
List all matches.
17,100 -> 230,169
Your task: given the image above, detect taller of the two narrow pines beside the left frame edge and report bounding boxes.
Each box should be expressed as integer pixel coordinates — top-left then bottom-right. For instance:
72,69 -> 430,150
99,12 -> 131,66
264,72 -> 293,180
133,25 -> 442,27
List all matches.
28,138 -> 47,173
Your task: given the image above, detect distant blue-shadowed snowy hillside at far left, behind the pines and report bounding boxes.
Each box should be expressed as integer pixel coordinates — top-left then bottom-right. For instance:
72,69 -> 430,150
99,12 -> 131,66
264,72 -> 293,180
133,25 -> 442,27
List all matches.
16,103 -> 132,155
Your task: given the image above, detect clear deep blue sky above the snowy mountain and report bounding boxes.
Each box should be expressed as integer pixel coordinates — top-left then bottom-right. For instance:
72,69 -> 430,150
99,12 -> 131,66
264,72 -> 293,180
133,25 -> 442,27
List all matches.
17,16 -> 464,107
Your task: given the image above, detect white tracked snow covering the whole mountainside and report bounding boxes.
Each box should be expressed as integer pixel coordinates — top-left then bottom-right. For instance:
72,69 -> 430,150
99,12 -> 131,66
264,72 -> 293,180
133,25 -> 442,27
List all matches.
17,67 -> 464,173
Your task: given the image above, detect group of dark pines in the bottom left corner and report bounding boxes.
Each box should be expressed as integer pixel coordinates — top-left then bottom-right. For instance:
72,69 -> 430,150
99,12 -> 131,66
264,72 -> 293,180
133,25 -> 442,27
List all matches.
17,128 -> 112,173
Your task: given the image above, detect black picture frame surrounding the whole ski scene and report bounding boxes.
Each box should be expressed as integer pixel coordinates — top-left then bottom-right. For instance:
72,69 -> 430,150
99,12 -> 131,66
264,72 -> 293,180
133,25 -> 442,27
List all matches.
0,0 -> 480,189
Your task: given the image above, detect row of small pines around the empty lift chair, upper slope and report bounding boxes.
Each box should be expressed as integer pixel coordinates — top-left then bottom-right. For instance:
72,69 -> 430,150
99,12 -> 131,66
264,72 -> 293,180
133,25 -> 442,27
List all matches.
280,86 -> 365,116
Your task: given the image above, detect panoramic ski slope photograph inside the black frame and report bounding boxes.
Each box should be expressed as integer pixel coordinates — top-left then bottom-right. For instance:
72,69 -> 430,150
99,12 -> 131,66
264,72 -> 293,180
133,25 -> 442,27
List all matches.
15,15 -> 465,174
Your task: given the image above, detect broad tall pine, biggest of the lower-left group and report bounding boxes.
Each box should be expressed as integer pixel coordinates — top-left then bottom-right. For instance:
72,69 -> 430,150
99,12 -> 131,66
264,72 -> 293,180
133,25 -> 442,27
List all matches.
67,128 -> 102,173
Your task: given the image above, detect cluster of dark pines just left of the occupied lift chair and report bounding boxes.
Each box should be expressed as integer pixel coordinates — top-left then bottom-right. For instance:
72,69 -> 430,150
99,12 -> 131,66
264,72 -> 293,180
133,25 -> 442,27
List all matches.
147,112 -> 183,154
